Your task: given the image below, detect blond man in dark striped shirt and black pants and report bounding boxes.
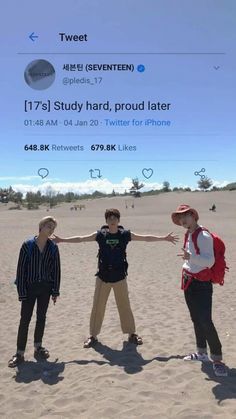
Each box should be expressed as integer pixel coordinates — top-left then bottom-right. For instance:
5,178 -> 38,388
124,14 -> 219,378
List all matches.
8,216 -> 61,368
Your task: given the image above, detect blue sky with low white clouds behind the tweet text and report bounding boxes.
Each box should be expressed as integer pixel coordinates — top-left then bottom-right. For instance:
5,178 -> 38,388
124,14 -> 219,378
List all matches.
0,0 -> 236,192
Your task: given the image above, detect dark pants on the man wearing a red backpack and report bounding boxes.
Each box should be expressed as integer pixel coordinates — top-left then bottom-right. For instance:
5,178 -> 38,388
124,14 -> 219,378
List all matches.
184,279 -> 222,361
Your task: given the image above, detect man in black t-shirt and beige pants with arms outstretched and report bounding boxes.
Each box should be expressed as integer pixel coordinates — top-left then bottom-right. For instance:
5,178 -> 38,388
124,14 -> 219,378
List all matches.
55,208 -> 178,348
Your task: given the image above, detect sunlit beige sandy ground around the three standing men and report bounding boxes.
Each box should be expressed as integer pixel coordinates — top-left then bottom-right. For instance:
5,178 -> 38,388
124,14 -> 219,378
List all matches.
0,192 -> 236,419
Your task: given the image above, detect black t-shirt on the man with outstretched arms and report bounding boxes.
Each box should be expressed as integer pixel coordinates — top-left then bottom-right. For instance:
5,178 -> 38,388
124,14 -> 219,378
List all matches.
96,228 -> 131,282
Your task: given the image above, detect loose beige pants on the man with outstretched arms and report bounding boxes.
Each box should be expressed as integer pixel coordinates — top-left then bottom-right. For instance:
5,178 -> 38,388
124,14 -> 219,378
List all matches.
90,278 -> 135,337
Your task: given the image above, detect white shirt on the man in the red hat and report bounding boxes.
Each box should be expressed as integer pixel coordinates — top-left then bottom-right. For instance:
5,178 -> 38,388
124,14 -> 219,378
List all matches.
183,231 -> 215,273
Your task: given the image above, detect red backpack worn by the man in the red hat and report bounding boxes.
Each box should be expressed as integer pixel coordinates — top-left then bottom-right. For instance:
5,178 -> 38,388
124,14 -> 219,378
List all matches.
184,227 -> 229,285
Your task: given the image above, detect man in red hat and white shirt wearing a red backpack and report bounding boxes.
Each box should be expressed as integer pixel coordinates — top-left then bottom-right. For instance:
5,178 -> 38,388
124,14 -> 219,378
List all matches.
171,204 -> 228,377
